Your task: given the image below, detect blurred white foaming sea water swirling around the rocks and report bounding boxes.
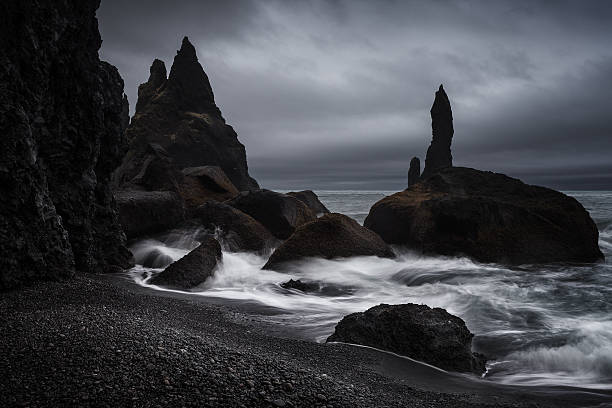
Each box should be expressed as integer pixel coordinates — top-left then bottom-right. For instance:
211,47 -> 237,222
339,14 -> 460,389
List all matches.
130,191 -> 612,389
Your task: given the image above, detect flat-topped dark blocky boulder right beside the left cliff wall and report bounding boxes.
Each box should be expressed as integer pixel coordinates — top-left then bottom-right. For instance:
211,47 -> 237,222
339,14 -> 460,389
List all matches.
115,190 -> 185,239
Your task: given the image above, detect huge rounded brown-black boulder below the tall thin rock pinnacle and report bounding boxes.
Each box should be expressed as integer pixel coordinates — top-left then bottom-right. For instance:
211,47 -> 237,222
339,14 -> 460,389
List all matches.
364,167 -> 603,264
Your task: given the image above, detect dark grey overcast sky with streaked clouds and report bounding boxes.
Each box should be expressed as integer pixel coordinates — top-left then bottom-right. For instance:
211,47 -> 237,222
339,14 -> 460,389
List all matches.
98,0 -> 612,190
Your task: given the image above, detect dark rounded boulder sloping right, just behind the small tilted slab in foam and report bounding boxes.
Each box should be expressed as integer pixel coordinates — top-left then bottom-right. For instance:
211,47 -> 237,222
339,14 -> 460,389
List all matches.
193,201 -> 276,253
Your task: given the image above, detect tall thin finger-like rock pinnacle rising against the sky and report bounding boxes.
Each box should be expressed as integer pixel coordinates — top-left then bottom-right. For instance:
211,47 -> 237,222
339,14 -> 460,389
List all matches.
422,85 -> 454,178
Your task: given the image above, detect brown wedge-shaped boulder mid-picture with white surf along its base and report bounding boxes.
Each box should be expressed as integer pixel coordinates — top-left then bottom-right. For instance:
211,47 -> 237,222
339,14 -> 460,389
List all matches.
264,213 -> 394,270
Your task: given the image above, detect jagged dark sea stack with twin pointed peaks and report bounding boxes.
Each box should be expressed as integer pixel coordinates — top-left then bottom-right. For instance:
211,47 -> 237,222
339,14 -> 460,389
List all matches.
115,37 -> 258,191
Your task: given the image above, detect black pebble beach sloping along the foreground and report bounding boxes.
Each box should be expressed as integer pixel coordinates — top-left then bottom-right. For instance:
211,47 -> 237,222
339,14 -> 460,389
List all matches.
0,274 -> 612,407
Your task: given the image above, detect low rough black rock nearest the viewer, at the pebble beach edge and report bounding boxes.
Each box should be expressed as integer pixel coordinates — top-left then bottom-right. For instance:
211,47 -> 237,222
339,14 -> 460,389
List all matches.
327,303 -> 486,374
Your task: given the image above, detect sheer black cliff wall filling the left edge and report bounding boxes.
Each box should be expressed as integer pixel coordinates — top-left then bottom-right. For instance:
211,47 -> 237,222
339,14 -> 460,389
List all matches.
0,0 -> 131,289
